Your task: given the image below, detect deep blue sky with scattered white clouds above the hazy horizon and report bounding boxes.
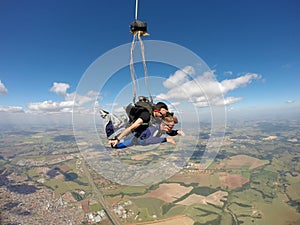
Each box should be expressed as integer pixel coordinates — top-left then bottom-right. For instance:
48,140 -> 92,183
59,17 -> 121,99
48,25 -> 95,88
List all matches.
0,0 -> 300,123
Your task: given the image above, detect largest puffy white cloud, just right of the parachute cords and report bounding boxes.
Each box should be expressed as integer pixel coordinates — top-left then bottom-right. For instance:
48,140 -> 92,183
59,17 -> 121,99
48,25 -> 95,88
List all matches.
157,67 -> 261,107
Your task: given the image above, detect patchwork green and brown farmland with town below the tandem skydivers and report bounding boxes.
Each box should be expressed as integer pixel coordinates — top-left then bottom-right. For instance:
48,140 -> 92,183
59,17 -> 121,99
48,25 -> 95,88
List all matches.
0,118 -> 300,225
